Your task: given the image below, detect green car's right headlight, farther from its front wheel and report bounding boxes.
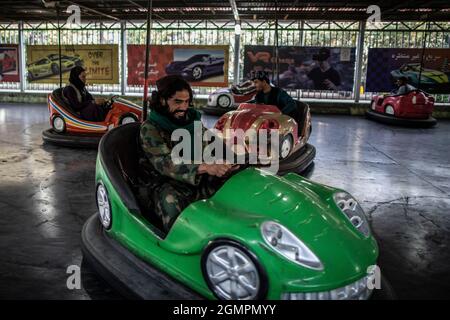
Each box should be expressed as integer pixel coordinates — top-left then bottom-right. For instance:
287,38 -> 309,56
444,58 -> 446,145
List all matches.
333,192 -> 370,237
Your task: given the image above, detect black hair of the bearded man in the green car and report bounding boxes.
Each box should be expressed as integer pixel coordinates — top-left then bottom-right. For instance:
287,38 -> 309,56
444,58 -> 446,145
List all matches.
150,75 -> 194,113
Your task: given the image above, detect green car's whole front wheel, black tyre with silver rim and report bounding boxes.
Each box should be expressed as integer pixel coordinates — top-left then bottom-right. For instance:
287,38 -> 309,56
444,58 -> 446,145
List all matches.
201,240 -> 267,300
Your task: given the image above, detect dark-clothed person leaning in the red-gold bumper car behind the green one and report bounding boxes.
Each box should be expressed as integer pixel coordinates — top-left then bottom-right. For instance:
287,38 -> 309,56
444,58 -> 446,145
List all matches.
251,71 -> 300,120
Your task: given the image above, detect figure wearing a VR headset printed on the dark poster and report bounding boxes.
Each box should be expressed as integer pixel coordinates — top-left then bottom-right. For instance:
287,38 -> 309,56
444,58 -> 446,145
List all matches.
308,48 -> 341,90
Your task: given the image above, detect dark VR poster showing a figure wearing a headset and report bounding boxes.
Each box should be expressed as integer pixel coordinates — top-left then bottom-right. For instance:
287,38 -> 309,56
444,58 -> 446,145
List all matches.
244,46 -> 355,91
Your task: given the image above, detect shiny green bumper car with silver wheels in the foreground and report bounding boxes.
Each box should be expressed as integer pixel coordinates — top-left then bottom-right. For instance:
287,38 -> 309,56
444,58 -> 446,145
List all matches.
82,123 -> 378,300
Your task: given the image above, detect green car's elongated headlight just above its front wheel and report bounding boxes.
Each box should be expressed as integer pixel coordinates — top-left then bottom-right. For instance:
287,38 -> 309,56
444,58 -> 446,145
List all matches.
261,221 -> 323,270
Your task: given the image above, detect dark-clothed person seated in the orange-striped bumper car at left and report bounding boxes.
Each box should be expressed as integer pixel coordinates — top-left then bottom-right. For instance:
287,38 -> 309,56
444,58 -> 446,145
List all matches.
63,66 -> 108,122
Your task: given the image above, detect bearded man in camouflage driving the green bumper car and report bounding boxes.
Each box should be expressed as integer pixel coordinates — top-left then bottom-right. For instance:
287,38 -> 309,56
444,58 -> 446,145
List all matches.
140,75 -> 237,231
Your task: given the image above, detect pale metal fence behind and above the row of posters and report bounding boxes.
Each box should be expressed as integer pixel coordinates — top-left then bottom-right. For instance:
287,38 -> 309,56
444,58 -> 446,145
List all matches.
0,20 -> 450,102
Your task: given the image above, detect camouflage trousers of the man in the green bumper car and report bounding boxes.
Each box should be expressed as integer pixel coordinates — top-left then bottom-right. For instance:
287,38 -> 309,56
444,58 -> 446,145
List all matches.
153,176 -> 224,232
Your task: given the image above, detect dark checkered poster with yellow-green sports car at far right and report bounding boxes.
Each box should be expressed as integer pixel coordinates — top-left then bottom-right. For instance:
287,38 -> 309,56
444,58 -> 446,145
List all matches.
366,48 -> 450,93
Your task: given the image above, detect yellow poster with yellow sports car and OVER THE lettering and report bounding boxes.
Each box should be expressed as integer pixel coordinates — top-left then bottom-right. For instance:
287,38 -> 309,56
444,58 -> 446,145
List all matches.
26,44 -> 119,84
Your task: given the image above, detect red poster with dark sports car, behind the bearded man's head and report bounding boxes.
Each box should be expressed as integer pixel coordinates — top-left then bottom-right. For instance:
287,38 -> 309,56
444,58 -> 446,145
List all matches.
127,45 -> 229,87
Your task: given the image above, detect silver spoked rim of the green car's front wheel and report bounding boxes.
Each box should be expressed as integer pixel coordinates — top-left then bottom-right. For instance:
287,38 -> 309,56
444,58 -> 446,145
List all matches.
206,245 -> 260,300
